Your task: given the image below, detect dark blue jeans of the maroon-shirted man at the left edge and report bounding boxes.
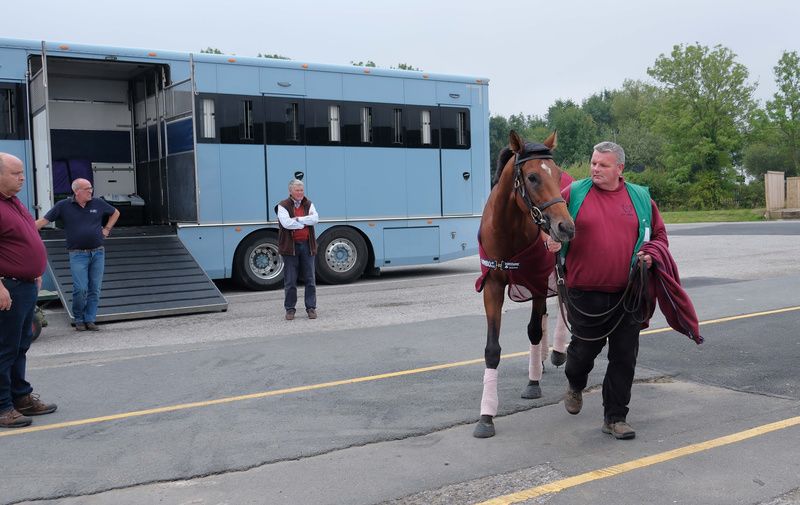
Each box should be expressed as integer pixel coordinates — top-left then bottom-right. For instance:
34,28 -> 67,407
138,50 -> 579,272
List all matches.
0,279 -> 39,412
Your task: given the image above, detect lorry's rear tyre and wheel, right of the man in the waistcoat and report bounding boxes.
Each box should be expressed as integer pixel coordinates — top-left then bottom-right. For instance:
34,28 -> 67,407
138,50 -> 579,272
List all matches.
316,226 -> 369,284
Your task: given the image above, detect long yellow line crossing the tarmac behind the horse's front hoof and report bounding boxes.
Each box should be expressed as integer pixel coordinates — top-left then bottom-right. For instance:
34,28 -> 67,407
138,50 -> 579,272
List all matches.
0,306 -> 800,438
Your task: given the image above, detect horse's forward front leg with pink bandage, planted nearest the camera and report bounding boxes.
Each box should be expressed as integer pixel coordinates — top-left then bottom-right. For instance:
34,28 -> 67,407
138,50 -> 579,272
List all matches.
472,277 -> 505,438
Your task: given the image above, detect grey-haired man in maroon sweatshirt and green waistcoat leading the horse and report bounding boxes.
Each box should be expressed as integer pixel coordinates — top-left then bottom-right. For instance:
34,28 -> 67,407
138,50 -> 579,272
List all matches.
548,142 -> 669,439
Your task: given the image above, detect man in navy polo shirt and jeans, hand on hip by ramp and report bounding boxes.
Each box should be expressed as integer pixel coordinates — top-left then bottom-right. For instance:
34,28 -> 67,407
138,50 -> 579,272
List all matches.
36,179 -> 119,331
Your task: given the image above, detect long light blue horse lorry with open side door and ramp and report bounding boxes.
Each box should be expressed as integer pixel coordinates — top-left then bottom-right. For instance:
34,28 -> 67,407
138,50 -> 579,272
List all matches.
0,38 -> 490,321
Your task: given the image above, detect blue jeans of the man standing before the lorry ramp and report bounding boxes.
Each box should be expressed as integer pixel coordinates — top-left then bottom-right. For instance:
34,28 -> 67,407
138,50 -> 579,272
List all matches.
69,247 -> 106,324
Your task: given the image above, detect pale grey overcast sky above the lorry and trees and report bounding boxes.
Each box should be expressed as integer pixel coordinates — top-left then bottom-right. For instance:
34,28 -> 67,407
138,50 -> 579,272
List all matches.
0,0 -> 800,116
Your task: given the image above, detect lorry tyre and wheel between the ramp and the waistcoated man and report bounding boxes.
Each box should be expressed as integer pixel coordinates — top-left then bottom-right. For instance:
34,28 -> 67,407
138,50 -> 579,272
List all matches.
233,231 -> 283,291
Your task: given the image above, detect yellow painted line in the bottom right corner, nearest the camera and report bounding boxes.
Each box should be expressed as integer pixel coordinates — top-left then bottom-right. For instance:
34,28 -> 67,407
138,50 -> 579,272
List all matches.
476,416 -> 800,505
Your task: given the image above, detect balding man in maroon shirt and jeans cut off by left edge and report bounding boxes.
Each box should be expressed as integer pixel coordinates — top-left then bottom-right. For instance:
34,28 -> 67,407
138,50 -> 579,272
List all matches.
0,153 -> 56,428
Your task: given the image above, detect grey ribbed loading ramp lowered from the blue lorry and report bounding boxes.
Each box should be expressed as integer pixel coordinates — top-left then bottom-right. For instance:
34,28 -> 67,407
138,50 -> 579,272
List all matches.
42,226 -> 228,322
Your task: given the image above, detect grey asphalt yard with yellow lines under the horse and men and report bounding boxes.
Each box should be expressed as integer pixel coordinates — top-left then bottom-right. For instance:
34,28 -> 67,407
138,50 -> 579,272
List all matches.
0,223 -> 800,505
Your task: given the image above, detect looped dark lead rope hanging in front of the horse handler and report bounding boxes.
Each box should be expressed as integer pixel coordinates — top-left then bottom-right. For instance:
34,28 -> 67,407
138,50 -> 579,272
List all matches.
556,254 -> 650,342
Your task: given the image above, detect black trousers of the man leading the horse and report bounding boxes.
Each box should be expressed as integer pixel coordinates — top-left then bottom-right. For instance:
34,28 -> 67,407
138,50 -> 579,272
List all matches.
564,289 -> 641,423
